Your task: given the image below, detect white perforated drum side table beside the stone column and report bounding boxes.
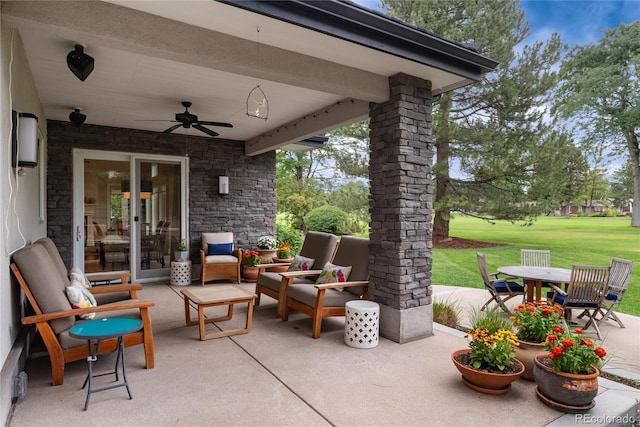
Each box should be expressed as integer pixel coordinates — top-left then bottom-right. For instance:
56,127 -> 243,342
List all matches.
344,300 -> 380,348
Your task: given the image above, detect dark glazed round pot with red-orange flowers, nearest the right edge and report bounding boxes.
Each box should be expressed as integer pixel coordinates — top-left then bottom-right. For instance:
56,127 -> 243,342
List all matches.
533,326 -> 607,412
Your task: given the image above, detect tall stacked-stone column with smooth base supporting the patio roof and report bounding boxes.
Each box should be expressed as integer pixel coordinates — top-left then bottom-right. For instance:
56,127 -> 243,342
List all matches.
369,74 -> 434,343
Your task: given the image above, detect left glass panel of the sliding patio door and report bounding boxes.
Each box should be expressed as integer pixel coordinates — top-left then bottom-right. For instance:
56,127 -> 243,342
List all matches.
84,159 -> 131,273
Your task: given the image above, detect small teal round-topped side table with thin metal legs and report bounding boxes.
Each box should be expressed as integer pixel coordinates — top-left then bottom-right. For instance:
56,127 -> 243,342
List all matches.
69,317 -> 142,411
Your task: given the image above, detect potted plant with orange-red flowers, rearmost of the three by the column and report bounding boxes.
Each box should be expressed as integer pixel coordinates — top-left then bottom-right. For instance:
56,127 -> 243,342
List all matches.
510,301 -> 564,381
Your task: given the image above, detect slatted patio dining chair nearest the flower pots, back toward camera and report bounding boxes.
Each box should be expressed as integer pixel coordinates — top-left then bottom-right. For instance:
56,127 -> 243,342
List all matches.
547,265 -> 610,339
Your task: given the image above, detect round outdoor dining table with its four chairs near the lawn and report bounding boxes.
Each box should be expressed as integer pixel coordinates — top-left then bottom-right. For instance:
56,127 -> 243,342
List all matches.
477,249 -> 633,339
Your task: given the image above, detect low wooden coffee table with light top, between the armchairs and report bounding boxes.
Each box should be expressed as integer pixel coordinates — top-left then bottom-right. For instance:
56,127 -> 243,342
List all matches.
180,285 -> 256,341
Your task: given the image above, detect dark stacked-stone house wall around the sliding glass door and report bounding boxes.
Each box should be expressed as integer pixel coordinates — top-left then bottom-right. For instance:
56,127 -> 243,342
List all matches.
47,121 -> 276,267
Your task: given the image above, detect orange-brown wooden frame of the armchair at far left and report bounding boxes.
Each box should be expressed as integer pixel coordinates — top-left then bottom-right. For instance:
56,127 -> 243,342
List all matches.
11,263 -> 155,386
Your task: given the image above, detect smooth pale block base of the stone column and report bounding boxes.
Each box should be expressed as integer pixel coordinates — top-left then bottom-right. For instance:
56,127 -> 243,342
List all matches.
380,304 -> 433,344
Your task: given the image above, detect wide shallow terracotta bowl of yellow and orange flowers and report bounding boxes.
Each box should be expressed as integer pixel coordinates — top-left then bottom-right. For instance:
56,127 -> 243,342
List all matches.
451,311 -> 524,394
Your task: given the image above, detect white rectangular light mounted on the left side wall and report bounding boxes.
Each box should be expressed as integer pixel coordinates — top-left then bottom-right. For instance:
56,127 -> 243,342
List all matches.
11,110 -> 39,168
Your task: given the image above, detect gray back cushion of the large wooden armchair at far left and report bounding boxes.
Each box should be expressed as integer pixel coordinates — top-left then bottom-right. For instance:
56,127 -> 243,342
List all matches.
13,244 -> 75,334
